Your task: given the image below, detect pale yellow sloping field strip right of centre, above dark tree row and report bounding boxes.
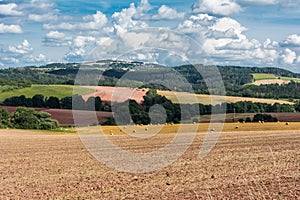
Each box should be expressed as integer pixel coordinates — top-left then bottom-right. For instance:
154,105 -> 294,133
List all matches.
157,90 -> 294,105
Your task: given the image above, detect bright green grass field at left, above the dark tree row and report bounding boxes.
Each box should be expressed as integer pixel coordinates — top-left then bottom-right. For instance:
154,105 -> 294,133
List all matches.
0,85 -> 94,102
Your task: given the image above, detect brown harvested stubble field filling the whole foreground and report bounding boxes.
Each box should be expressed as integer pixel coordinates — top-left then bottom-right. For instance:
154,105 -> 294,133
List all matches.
0,123 -> 300,199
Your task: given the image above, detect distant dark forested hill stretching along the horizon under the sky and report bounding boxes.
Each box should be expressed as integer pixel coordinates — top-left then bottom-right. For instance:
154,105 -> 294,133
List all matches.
0,60 -> 300,100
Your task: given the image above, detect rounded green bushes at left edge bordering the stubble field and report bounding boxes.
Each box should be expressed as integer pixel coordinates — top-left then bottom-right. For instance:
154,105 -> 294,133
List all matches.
0,107 -> 59,130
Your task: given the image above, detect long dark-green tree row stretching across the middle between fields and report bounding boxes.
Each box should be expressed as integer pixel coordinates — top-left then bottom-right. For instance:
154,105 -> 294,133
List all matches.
2,90 -> 300,115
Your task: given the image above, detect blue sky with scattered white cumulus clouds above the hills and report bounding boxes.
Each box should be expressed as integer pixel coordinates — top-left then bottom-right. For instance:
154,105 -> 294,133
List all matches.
0,0 -> 300,72
